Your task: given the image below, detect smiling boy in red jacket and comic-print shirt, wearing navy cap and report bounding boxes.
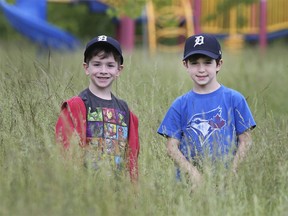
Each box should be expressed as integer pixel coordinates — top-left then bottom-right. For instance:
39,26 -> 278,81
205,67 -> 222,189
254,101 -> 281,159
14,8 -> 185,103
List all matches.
55,35 -> 140,180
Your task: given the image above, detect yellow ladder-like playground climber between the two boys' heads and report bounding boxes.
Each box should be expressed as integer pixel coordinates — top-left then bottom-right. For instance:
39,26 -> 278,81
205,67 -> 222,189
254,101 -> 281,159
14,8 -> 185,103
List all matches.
147,0 -> 194,53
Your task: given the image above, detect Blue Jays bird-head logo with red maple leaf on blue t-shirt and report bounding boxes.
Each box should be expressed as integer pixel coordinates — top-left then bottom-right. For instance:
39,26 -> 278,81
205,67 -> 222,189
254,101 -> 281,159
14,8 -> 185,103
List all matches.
187,107 -> 226,146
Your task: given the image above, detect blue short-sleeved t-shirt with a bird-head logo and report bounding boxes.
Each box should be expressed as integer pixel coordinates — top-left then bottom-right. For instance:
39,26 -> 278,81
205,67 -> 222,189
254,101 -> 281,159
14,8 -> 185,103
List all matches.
157,85 -> 256,160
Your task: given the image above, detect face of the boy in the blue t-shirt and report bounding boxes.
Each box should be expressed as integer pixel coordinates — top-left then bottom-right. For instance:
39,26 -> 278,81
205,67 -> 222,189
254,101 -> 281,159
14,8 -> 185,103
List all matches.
183,55 -> 222,90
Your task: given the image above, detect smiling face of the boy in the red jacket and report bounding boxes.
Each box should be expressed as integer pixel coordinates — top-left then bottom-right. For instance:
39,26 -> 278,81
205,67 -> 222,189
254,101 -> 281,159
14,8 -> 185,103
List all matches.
83,53 -> 123,91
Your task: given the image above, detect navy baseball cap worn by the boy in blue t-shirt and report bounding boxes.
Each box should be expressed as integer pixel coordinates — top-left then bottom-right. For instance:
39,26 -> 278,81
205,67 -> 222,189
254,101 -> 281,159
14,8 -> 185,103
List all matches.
183,34 -> 222,61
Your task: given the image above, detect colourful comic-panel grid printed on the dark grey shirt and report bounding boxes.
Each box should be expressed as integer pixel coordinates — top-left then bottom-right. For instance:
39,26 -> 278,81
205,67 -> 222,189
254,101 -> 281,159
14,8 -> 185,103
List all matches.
86,108 -> 128,169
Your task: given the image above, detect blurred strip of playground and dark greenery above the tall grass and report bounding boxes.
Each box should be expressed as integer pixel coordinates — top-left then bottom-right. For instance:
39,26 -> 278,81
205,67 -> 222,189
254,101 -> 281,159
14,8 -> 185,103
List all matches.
0,0 -> 288,53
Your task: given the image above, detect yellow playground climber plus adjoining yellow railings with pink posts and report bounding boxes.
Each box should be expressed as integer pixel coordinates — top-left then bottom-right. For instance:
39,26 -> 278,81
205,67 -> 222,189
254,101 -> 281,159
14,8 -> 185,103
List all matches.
147,0 -> 288,53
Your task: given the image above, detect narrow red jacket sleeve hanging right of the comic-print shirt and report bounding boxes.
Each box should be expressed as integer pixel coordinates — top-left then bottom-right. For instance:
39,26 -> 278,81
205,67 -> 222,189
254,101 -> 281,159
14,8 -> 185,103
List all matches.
128,111 -> 140,181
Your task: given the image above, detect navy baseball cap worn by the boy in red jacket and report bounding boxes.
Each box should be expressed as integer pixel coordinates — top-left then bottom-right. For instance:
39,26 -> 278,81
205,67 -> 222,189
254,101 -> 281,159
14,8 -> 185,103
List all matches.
84,35 -> 124,65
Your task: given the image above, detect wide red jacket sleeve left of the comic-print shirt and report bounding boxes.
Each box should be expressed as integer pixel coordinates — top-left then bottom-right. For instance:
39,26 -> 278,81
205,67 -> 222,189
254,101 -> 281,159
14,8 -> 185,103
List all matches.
55,96 -> 86,149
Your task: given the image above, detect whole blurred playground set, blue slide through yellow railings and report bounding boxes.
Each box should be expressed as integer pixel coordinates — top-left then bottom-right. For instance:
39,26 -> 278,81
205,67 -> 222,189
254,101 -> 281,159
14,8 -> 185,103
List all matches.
0,0 -> 288,53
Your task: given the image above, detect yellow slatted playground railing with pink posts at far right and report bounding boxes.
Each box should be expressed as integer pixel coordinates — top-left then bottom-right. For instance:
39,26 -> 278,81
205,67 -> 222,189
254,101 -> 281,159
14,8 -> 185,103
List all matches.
192,0 -> 288,48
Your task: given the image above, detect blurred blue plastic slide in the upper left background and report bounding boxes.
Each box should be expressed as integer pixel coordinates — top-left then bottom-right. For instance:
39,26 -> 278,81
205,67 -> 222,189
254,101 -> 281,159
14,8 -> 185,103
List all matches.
0,0 -> 80,50
